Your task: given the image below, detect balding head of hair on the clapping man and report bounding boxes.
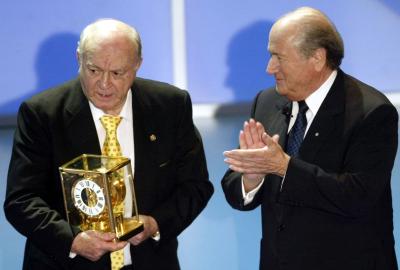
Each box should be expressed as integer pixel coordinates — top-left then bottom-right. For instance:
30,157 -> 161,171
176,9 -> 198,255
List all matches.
279,7 -> 344,69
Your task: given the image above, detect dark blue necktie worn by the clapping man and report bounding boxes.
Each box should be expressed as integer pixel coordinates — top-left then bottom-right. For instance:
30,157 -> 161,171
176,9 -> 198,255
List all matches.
286,100 -> 308,157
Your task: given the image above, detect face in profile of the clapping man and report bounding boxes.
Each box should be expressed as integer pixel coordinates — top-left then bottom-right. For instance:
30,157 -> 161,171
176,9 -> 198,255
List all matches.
267,25 -> 318,101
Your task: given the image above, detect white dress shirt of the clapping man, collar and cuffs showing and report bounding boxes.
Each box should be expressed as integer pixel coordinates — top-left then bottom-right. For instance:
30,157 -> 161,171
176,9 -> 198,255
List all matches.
242,70 -> 337,205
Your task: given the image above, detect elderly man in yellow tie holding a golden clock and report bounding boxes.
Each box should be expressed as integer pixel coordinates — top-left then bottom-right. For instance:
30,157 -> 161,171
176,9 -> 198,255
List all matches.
4,19 -> 213,270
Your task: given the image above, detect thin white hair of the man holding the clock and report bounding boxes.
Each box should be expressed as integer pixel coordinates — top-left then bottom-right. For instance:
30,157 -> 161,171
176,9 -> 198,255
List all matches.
76,19 -> 142,59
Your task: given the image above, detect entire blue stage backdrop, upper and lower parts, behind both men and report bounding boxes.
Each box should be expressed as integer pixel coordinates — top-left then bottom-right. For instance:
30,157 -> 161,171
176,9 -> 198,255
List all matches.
0,0 -> 400,270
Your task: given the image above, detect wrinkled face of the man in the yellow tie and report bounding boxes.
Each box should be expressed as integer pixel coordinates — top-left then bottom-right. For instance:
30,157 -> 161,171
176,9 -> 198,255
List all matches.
78,37 -> 141,115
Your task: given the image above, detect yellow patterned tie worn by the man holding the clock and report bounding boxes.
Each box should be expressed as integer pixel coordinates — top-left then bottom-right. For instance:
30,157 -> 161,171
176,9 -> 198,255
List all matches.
100,115 -> 124,270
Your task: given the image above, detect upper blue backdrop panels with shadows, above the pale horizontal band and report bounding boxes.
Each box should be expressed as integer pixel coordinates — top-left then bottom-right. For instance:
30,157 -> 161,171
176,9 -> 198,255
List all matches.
0,0 -> 400,116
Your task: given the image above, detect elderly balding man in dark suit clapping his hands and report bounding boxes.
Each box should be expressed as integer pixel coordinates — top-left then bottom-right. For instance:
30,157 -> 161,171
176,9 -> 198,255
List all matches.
222,8 -> 398,270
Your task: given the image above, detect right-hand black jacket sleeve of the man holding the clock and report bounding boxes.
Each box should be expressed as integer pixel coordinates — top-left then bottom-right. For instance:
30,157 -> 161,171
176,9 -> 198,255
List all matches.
151,90 -> 213,240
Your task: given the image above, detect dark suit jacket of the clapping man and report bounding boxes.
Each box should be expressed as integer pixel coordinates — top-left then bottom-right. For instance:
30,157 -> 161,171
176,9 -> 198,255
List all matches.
222,70 -> 398,270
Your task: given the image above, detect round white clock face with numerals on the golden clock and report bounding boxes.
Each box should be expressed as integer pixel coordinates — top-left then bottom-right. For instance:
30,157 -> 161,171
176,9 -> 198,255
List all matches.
72,179 -> 105,216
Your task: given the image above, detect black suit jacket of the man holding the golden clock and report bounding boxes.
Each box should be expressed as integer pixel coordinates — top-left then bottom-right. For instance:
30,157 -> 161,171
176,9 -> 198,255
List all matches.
4,78 -> 213,270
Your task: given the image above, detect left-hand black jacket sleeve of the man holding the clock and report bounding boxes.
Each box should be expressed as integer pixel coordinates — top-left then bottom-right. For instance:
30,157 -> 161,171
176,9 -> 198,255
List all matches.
4,103 -> 76,261
